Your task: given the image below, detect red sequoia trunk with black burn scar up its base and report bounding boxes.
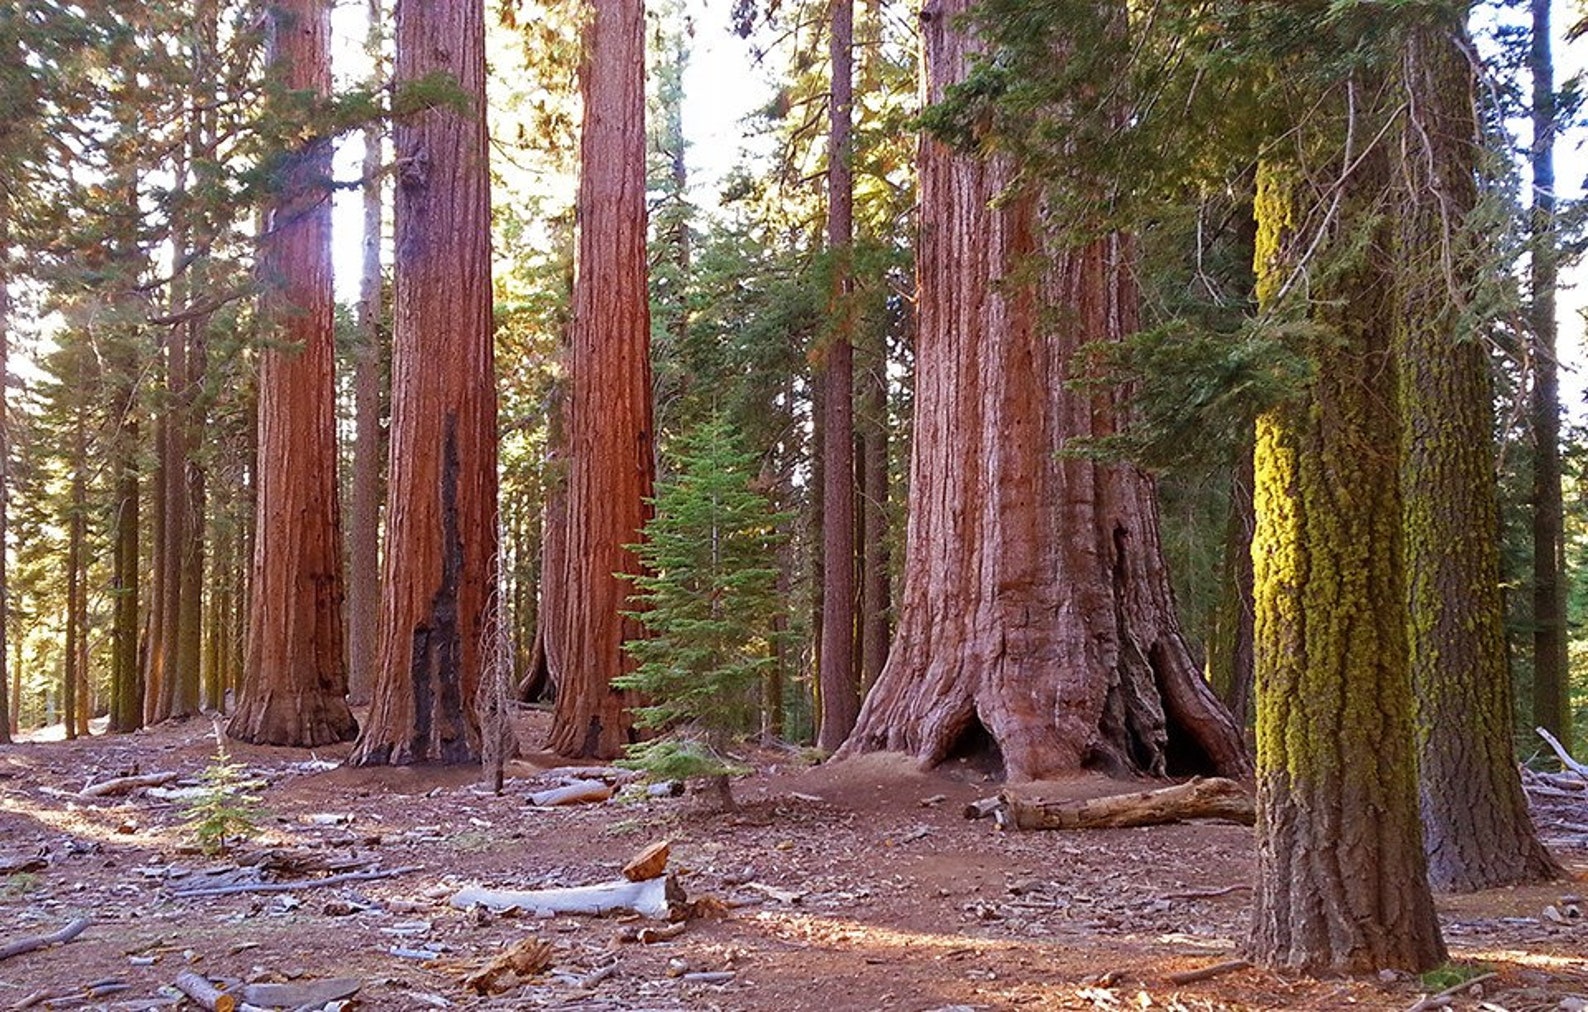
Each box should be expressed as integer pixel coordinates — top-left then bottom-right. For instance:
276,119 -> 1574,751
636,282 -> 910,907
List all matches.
348,0 -> 492,766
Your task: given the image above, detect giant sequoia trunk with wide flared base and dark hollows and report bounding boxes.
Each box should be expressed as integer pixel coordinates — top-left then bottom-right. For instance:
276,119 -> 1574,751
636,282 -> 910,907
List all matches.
840,0 -> 1250,780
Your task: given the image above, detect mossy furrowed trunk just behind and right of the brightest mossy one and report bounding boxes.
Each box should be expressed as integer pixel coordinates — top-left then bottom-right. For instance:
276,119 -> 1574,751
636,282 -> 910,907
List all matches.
1396,19 -> 1561,891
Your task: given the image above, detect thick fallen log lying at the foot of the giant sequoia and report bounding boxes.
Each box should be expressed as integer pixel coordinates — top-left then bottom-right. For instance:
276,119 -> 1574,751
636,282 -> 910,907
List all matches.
999,777 -> 1256,829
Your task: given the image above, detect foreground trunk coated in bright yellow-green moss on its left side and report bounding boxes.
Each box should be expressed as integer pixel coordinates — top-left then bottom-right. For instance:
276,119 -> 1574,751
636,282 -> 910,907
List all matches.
1250,154 -> 1445,974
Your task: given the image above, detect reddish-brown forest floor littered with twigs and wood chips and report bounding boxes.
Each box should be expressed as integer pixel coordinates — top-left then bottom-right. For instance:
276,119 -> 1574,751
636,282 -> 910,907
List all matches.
0,710 -> 1588,1012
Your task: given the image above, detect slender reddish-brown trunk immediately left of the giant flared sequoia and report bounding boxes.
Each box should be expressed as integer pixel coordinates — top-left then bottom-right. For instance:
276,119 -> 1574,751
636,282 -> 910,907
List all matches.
816,0 -> 861,751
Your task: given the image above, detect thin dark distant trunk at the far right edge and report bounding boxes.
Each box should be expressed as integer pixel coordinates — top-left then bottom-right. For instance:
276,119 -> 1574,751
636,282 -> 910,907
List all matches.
1528,0 -> 1572,748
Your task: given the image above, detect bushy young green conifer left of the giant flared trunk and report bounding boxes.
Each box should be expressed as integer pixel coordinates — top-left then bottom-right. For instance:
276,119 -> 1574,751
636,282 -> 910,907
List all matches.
613,418 -> 788,807
